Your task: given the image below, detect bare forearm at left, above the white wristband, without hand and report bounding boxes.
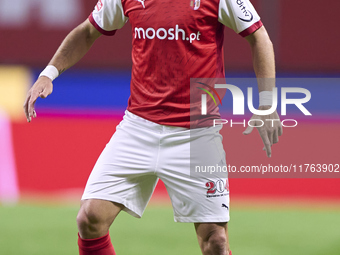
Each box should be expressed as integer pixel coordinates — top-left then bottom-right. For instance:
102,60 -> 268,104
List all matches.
49,20 -> 100,74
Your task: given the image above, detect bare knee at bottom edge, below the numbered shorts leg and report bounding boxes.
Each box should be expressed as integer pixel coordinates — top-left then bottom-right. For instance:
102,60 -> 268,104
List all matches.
202,231 -> 229,255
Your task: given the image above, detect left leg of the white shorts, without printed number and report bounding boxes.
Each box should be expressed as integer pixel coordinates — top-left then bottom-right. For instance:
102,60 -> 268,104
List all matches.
82,114 -> 158,217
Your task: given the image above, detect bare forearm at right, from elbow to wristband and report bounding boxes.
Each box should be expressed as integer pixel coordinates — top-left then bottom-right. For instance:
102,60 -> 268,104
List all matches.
247,27 -> 275,92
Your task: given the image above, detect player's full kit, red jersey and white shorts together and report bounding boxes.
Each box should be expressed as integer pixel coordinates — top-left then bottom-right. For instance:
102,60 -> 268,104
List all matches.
83,0 -> 262,222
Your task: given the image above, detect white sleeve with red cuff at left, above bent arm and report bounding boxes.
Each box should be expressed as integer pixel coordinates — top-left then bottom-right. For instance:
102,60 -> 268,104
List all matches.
89,0 -> 128,35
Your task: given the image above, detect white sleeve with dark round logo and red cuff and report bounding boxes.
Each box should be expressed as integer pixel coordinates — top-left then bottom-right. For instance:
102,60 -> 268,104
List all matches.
218,0 -> 263,37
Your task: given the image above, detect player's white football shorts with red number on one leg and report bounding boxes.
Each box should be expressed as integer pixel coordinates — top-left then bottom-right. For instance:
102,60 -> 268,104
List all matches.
82,111 -> 229,222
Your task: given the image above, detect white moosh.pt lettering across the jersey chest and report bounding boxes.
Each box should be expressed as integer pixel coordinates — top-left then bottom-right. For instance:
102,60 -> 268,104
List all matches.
134,25 -> 201,43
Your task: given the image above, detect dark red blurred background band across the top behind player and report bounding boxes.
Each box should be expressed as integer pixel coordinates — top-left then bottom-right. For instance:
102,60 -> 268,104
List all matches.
0,0 -> 340,73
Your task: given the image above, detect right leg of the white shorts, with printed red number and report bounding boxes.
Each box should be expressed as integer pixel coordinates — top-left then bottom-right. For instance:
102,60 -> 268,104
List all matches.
159,126 -> 229,223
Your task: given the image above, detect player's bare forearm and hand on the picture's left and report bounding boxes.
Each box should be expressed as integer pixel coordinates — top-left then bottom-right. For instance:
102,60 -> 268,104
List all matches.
24,19 -> 101,122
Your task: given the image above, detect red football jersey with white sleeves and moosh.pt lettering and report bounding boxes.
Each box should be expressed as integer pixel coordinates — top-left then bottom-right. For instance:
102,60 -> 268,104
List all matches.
89,0 -> 262,128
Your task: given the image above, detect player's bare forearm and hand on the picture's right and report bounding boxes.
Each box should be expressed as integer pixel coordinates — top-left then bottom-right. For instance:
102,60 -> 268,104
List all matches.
243,26 -> 282,157
